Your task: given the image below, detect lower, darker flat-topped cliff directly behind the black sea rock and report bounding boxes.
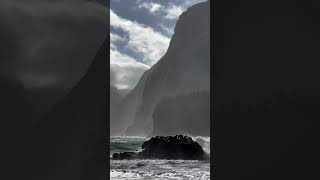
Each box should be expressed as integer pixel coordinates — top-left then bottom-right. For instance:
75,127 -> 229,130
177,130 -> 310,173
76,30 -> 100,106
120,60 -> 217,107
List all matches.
152,91 -> 210,136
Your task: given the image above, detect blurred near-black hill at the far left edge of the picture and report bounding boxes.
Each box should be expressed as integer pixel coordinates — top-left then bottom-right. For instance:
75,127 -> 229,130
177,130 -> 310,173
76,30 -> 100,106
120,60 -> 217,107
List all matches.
0,76 -> 34,179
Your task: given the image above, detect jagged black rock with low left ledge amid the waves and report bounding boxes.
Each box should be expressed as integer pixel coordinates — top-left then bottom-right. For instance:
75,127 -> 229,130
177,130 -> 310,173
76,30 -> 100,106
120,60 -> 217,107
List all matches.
112,135 -> 205,160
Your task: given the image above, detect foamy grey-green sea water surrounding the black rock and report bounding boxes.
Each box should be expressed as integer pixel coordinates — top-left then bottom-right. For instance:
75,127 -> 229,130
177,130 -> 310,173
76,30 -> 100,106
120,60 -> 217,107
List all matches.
110,136 -> 210,180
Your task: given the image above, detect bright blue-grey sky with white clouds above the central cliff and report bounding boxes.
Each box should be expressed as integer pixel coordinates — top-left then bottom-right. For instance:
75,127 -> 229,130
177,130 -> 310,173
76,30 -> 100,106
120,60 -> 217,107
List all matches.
110,0 -> 206,90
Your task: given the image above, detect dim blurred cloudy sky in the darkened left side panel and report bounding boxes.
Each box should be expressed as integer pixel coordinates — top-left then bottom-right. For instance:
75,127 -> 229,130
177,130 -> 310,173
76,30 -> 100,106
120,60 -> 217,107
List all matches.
0,0 -> 109,87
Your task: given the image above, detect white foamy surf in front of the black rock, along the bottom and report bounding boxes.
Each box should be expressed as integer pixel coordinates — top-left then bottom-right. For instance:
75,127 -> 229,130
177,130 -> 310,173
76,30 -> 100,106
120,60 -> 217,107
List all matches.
110,160 -> 210,180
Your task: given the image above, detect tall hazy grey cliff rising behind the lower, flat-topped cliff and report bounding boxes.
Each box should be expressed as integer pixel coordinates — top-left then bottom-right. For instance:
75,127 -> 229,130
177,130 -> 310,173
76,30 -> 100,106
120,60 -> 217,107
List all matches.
120,2 -> 210,135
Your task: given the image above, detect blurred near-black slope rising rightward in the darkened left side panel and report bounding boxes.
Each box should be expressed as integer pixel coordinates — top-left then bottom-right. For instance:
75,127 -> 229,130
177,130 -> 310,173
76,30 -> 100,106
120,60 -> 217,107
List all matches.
18,40 -> 109,180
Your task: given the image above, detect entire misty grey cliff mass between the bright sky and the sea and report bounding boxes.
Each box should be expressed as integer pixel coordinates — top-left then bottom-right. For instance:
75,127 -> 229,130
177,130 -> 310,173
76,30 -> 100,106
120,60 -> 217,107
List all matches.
110,2 -> 210,136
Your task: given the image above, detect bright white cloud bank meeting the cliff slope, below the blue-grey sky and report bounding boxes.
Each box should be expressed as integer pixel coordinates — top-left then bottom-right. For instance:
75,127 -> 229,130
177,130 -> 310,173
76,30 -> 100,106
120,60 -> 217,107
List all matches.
110,10 -> 169,89
